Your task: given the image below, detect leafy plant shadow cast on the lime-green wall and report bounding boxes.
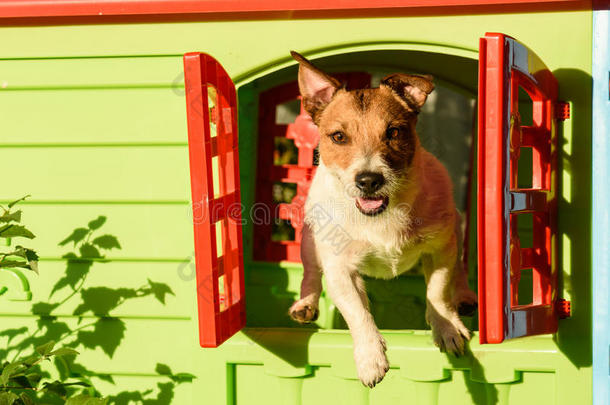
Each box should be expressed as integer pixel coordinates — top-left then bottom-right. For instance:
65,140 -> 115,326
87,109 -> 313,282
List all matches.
0,216 -> 195,405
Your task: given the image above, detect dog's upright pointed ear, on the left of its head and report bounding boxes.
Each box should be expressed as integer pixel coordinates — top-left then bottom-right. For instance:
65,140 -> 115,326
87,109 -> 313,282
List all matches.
290,51 -> 341,121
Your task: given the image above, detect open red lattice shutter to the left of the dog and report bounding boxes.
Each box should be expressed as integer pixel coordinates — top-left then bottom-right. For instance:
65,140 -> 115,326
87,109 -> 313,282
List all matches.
184,52 -> 246,347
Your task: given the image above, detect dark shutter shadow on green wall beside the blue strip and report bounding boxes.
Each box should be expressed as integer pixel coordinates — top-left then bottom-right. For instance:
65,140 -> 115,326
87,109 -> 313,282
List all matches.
553,69 -> 592,368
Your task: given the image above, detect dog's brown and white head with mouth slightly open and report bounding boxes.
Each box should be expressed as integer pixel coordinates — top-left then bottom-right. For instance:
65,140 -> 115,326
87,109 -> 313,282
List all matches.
291,52 -> 434,216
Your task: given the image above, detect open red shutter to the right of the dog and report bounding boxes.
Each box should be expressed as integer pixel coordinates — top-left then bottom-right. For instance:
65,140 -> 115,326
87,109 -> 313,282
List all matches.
477,34 -> 563,343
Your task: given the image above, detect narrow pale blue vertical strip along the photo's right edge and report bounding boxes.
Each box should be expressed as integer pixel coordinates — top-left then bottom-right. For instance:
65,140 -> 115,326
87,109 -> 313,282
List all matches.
592,10 -> 610,405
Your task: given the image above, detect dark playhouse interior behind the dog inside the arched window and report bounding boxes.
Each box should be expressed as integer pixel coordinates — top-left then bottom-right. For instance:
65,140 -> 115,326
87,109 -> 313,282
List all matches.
228,50 -> 532,330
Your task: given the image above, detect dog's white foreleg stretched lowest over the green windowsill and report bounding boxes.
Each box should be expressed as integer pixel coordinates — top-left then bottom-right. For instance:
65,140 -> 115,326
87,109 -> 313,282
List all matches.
322,252 -> 390,388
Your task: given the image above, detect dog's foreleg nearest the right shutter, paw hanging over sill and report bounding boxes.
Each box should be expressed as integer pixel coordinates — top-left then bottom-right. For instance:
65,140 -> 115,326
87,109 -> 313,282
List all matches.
422,239 -> 470,355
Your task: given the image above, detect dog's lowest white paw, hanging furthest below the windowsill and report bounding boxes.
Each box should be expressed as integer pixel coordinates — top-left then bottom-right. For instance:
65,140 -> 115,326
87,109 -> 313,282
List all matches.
354,335 -> 390,388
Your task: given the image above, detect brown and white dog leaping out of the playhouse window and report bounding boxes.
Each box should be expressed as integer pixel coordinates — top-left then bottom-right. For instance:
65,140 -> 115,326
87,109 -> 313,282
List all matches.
289,52 -> 476,387
